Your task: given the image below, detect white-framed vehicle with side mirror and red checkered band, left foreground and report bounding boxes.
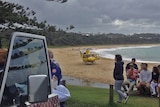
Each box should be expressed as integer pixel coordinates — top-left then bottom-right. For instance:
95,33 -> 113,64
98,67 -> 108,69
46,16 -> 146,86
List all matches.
0,32 -> 60,107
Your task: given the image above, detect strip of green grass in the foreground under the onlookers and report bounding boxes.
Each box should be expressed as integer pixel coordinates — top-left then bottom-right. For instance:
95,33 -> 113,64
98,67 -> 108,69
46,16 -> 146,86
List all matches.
66,86 -> 158,107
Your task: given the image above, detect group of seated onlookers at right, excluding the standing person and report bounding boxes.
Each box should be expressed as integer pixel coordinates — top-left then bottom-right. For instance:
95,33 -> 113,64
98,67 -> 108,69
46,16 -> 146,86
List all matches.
122,58 -> 160,97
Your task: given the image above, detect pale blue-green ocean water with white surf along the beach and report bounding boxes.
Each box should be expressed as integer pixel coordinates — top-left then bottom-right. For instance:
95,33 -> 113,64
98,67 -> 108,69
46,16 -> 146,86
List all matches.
95,45 -> 160,63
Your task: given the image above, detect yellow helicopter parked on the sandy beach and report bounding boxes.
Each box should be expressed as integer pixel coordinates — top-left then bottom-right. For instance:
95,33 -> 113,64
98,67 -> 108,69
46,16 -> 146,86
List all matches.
80,48 -> 100,64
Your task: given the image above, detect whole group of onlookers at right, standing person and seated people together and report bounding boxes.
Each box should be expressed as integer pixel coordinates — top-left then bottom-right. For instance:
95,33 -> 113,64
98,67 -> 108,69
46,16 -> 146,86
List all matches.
113,54 -> 160,104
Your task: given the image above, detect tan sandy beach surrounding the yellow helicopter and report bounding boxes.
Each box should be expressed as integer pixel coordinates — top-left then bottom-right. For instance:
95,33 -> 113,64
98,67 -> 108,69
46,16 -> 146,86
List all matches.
50,45 -> 158,84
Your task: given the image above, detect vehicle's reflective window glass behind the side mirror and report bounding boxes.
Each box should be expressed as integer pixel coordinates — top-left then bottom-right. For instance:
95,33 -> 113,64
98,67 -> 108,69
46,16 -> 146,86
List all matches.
0,36 -> 49,104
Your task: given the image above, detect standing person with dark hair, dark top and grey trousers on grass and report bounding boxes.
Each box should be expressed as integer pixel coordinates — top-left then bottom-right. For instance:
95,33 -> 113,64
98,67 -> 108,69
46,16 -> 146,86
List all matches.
113,54 -> 129,103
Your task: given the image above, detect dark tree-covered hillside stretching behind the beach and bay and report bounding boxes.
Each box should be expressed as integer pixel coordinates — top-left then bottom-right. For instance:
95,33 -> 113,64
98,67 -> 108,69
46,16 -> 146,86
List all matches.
0,1 -> 160,46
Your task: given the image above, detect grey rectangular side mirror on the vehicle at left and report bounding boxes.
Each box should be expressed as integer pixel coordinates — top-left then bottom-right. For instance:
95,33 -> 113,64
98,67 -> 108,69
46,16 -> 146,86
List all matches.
28,75 -> 48,103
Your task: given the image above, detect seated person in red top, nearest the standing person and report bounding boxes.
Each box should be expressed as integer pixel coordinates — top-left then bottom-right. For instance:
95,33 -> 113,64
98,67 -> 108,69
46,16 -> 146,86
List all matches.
123,64 -> 138,94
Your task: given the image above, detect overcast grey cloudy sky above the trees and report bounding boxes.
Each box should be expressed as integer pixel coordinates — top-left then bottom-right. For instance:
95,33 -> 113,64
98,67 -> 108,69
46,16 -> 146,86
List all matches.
5,0 -> 160,34
